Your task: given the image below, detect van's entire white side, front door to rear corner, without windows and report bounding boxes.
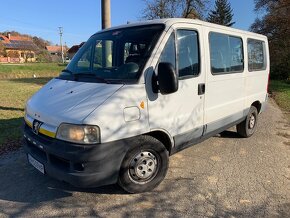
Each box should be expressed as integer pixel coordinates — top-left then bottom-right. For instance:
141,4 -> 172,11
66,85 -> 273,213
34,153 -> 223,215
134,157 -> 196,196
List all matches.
145,20 -> 269,150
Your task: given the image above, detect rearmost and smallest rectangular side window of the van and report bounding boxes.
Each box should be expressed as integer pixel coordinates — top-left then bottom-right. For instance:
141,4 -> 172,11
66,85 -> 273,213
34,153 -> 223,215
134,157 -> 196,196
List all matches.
248,39 -> 266,71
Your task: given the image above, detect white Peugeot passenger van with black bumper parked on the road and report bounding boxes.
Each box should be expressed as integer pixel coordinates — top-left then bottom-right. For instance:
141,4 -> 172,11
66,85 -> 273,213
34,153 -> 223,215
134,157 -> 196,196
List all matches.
24,19 -> 270,193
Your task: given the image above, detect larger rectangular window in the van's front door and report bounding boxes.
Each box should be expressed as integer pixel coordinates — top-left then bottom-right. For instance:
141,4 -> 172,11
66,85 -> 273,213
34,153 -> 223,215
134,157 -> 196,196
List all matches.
177,30 -> 200,78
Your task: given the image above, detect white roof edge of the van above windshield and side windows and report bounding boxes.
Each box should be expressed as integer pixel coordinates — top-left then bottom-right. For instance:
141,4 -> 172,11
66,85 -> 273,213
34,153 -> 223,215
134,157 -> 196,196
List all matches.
95,18 -> 266,38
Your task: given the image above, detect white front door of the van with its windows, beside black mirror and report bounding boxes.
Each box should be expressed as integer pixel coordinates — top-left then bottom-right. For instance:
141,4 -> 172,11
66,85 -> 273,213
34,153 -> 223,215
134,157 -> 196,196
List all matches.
148,24 -> 205,147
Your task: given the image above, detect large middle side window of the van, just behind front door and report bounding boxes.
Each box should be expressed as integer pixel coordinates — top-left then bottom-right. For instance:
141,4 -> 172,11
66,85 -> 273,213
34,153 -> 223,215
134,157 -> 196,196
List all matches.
209,32 -> 244,75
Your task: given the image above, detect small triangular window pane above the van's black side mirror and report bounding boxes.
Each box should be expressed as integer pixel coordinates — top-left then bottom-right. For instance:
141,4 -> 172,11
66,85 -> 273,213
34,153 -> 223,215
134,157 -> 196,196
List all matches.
159,33 -> 176,69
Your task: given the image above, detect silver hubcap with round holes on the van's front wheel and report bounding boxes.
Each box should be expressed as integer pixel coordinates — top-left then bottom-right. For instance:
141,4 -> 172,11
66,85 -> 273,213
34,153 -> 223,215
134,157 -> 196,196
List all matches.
129,151 -> 157,182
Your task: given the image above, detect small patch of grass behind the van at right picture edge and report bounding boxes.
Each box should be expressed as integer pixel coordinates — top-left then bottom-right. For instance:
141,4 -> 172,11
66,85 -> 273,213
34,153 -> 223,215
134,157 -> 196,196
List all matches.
269,80 -> 290,120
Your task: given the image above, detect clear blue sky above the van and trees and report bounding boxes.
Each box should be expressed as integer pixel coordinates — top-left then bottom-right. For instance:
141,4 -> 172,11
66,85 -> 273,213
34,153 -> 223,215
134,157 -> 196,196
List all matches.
0,0 -> 257,47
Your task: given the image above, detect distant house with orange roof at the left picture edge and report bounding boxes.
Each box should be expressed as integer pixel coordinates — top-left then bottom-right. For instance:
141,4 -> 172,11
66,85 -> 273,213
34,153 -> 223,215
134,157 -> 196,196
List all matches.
0,34 -> 38,63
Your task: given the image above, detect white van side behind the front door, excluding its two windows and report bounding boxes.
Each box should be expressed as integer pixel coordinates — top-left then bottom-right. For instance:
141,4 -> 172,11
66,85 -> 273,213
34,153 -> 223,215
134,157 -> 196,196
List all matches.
205,27 -> 269,134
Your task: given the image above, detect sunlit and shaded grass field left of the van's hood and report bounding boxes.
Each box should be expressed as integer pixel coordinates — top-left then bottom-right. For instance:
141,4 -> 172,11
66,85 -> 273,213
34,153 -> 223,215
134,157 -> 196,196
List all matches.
0,63 -> 64,151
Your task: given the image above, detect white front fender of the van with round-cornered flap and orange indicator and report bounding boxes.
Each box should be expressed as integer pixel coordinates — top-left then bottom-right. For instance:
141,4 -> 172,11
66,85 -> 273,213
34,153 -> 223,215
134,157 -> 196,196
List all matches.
83,84 -> 150,143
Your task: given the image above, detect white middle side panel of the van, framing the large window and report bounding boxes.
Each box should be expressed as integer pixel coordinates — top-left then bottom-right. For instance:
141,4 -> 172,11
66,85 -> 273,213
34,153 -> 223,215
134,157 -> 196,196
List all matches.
205,27 -> 245,133
